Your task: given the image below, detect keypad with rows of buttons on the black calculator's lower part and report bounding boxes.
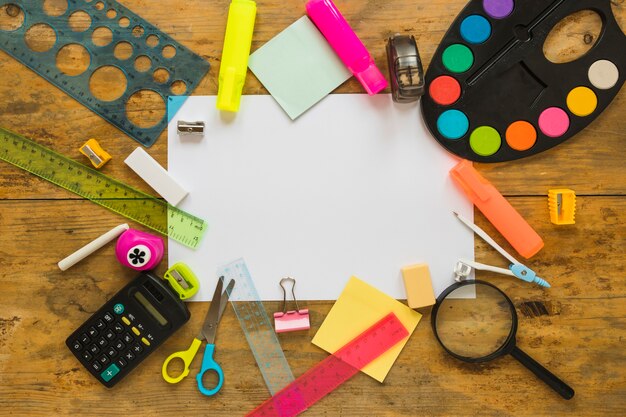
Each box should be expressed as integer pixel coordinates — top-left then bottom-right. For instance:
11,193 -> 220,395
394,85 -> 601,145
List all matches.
71,306 -> 154,382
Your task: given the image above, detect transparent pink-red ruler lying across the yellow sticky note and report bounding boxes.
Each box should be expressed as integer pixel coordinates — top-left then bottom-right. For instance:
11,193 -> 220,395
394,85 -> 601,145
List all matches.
248,313 -> 409,417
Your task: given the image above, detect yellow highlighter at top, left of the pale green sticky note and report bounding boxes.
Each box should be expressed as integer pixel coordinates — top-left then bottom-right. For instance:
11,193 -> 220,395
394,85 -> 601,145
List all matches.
216,0 -> 256,112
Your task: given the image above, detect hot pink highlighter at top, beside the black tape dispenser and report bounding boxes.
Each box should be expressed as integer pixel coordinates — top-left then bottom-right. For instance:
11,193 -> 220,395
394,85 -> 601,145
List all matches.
306,0 -> 387,96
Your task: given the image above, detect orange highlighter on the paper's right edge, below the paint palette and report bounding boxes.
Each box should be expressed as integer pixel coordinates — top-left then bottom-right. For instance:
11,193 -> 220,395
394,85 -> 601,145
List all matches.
450,160 -> 543,259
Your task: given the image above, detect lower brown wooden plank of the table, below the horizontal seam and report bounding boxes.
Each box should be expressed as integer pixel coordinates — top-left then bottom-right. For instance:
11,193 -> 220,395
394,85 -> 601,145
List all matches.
0,197 -> 626,416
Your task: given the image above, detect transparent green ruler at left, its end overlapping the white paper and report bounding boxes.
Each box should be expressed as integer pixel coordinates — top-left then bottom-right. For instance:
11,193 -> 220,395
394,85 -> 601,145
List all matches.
0,127 -> 208,249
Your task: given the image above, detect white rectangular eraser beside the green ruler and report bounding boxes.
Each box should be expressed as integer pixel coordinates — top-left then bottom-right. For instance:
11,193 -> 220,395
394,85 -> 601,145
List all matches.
124,148 -> 189,206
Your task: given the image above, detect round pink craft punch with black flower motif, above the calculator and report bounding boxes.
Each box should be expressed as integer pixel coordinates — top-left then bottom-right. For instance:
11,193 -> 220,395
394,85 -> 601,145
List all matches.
115,229 -> 165,271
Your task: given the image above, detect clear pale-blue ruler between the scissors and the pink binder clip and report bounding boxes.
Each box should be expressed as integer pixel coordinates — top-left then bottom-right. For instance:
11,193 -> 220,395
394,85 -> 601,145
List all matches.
218,259 -> 294,395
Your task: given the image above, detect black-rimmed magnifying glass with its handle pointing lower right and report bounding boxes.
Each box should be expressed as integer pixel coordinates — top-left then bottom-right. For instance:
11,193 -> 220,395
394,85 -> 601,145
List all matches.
431,280 -> 574,400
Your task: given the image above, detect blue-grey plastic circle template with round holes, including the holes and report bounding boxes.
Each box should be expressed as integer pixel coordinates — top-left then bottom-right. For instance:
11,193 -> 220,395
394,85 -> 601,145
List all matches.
0,0 -> 209,146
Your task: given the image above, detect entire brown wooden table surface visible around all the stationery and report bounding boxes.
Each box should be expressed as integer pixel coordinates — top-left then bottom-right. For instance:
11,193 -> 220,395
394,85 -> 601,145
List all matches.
0,0 -> 626,416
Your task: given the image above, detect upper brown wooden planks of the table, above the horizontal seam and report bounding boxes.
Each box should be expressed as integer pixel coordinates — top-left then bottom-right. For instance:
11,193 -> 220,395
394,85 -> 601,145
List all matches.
0,0 -> 626,198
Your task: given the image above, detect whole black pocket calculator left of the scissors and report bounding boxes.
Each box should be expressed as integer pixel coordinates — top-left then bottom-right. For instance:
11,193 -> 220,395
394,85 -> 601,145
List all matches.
65,272 -> 191,388
